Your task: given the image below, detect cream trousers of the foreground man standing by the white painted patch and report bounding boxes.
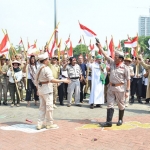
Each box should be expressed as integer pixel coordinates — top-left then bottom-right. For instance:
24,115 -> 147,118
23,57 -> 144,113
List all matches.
38,93 -> 53,126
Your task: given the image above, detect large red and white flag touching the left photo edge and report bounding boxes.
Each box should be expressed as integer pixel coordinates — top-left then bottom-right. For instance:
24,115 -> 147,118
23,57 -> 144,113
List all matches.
0,34 -> 10,55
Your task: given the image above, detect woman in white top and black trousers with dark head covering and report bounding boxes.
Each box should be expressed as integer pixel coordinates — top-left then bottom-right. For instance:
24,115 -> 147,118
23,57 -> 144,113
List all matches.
26,55 -> 39,107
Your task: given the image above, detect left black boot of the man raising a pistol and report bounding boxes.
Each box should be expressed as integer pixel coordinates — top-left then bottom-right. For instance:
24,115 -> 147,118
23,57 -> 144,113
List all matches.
100,108 -> 114,127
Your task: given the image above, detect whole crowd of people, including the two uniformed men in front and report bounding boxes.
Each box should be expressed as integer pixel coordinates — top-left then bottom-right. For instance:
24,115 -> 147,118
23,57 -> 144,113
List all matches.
0,43 -> 150,129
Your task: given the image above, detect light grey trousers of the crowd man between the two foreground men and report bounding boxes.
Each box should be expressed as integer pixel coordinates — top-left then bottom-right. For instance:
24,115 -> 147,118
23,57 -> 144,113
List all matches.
67,79 -> 80,104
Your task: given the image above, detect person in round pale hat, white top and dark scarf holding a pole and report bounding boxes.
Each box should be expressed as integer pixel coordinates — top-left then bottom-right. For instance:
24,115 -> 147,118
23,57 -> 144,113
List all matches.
7,60 -> 23,107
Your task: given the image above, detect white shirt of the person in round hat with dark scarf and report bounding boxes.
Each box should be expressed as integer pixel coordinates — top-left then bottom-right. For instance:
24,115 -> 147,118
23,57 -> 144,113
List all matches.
7,69 -> 23,83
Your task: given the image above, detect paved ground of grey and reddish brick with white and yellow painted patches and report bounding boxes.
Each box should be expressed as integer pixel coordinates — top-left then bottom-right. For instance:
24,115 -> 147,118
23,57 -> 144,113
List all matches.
0,98 -> 150,150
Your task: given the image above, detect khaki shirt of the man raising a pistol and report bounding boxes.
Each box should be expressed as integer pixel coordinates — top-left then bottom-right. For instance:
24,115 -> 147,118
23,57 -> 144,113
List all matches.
106,58 -> 130,92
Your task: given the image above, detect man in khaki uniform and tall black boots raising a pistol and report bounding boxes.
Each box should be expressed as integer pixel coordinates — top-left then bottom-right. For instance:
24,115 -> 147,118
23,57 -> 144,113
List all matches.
96,43 -> 130,127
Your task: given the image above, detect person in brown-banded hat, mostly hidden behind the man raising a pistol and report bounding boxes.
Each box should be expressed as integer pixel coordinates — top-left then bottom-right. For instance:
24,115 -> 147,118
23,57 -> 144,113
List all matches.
124,57 -> 134,107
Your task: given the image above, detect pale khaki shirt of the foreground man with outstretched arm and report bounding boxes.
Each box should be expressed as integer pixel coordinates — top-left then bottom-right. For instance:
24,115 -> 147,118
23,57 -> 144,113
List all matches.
35,64 -> 54,95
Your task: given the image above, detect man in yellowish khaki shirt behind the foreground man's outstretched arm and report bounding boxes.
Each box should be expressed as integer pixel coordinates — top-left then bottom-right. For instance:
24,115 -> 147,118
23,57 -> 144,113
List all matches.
49,57 -> 60,108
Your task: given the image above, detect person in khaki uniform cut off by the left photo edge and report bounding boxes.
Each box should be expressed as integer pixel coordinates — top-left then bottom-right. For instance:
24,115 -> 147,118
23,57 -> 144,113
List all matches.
0,56 -> 8,105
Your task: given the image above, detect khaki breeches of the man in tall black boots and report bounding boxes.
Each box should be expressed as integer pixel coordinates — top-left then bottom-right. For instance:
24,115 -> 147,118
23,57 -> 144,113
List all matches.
107,88 -> 125,110
